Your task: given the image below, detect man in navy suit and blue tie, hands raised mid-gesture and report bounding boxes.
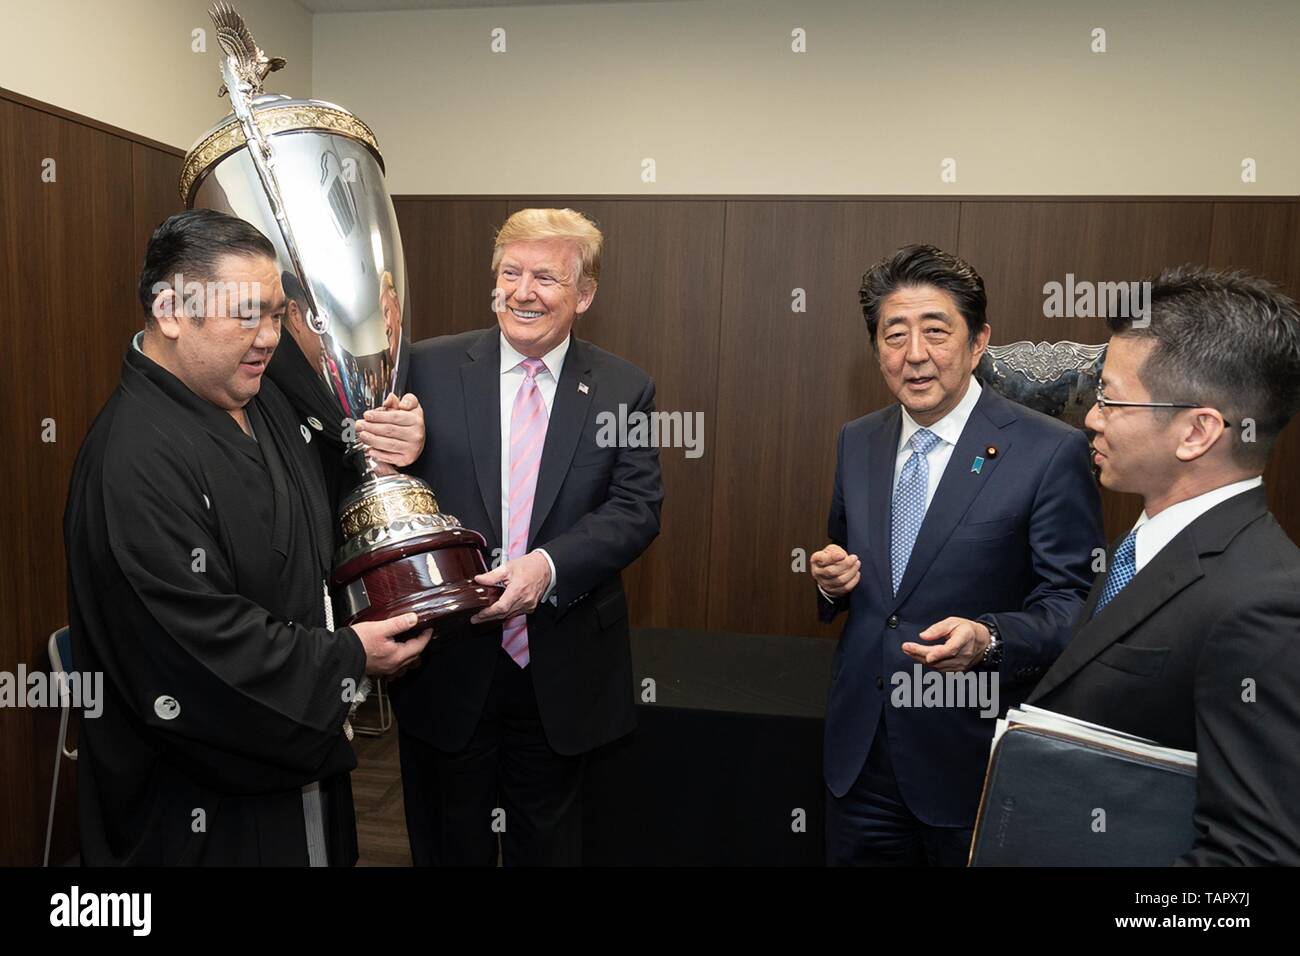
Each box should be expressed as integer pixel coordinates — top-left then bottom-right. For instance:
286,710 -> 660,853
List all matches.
811,246 -> 1102,866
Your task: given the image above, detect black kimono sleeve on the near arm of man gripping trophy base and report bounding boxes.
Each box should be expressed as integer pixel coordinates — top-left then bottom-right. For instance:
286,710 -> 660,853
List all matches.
81,442 -> 365,793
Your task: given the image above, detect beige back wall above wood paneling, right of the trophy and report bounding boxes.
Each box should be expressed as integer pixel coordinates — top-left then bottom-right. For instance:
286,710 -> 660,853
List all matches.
312,0 -> 1300,195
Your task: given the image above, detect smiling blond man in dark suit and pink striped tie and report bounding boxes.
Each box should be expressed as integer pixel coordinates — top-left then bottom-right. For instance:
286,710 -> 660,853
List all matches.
393,209 -> 663,865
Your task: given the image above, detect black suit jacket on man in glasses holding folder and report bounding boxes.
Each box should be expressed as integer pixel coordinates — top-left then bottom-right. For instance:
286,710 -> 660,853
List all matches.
1030,488 -> 1300,866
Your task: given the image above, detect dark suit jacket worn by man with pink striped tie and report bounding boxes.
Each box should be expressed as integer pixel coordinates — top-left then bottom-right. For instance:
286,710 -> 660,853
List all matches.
393,326 -> 663,754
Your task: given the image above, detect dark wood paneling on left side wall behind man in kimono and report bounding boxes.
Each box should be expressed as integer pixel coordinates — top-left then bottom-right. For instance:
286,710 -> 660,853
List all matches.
0,90 -> 181,865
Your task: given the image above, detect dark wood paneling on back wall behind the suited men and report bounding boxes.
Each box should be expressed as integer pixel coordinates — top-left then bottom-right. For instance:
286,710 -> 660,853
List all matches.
397,196 -> 1300,636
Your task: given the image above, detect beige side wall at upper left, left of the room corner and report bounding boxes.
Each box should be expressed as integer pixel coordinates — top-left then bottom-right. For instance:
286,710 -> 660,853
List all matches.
0,0 -> 312,150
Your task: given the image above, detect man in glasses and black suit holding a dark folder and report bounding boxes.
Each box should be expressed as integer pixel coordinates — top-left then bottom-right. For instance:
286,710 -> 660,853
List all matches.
1030,268 -> 1300,866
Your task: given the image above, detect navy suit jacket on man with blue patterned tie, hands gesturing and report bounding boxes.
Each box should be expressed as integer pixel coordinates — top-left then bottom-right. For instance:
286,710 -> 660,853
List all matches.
818,389 -> 1104,827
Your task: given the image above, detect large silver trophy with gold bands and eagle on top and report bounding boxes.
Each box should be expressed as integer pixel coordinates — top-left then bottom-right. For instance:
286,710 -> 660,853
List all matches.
181,3 -> 501,630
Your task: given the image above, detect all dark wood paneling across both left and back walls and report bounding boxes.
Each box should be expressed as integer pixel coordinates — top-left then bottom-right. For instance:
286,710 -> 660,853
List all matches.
0,83 -> 1300,865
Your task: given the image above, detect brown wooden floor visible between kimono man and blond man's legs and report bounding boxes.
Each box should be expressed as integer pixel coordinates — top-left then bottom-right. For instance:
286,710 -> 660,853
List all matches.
352,698 -> 411,866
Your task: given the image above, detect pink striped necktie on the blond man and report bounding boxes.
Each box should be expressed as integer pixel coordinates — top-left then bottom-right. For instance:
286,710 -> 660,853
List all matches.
501,359 -> 549,667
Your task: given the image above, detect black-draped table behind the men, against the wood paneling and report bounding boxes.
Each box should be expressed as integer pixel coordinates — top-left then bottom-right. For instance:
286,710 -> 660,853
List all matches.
582,630 -> 835,866
